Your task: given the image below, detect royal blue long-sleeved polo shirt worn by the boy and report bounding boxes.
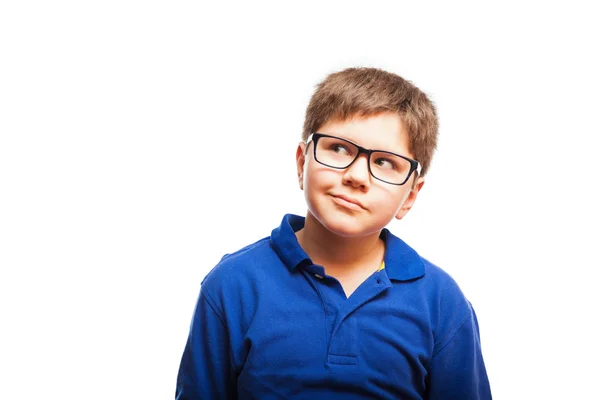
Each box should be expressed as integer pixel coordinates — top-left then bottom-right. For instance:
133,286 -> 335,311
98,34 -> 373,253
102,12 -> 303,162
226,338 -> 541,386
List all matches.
176,214 -> 491,400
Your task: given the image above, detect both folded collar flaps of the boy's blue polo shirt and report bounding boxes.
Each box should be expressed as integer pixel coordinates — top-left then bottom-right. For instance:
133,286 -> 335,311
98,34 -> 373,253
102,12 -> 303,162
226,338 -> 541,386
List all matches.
271,214 -> 425,281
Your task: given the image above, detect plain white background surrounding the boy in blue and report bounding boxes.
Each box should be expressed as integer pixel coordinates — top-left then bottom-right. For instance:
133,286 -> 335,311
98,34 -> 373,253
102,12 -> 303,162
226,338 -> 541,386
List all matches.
0,0 -> 600,399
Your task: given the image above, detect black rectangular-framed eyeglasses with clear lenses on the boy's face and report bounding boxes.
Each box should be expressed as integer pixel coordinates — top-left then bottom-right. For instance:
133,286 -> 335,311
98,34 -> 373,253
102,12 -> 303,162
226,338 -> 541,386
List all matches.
306,132 -> 421,185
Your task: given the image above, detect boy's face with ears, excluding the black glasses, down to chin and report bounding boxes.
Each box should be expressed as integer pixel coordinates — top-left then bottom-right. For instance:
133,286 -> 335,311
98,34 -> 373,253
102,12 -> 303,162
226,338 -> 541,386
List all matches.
296,113 -> 424,237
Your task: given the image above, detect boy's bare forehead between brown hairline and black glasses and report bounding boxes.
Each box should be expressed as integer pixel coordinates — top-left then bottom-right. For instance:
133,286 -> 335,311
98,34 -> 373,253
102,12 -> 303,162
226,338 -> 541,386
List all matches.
317,113 -> 412,155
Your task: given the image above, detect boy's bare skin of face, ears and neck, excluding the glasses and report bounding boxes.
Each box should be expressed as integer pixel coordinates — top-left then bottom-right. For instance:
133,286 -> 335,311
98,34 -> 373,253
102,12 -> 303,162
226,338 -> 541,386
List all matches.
296,113 -> 424,297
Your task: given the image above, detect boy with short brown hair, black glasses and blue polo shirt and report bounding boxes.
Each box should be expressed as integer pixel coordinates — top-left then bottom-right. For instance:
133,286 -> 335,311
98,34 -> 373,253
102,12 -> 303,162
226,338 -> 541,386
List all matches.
176,68 -> 491,400
